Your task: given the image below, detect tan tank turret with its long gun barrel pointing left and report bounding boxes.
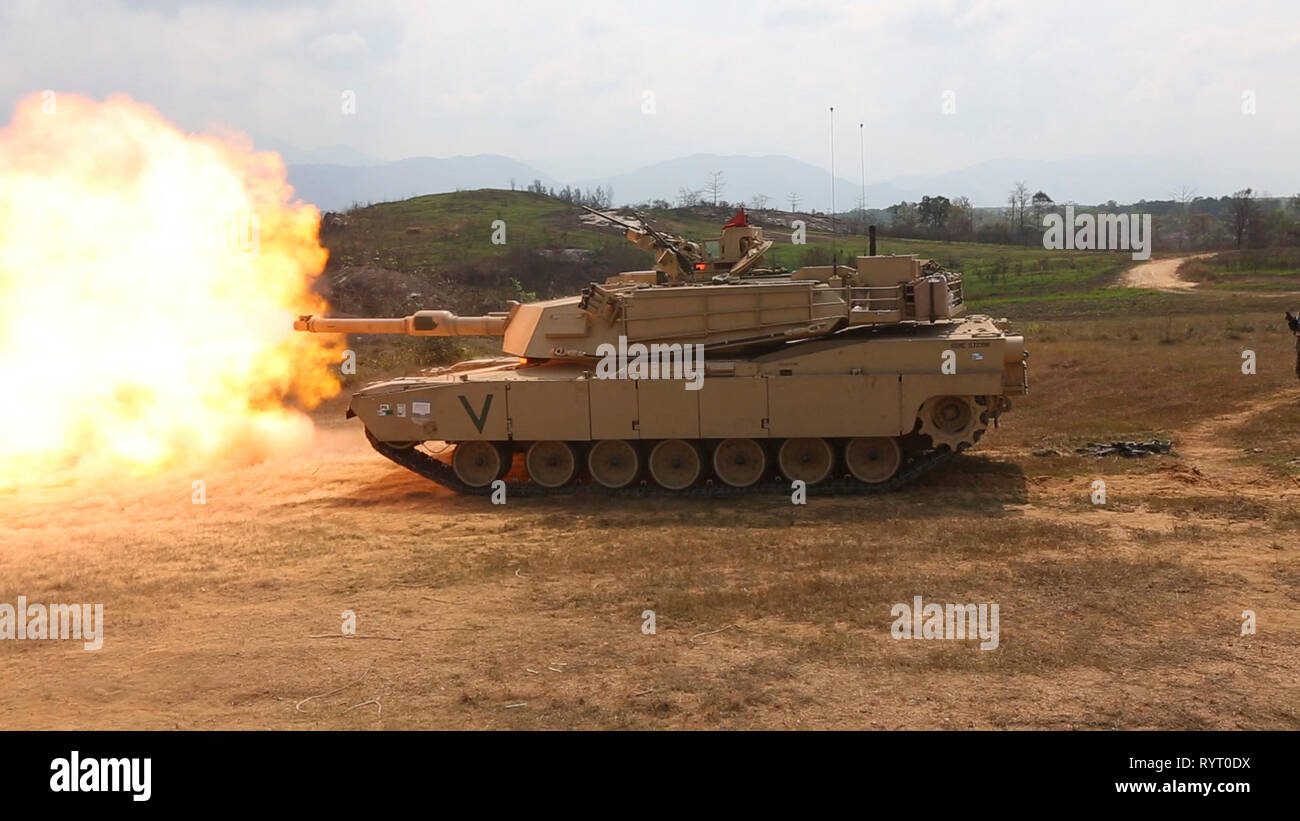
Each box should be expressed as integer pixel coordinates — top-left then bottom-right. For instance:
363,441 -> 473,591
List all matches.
304,256 -> 965,360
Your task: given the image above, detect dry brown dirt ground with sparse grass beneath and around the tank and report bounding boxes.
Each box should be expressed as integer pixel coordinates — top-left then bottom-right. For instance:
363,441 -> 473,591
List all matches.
0,318 -> 1300,729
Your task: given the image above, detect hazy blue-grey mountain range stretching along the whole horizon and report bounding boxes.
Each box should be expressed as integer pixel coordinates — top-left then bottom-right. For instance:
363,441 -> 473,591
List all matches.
276,147 -> 1295,213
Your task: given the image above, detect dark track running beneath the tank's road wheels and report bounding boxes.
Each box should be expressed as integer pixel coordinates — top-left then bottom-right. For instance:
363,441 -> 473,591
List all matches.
365,430 -> 966,499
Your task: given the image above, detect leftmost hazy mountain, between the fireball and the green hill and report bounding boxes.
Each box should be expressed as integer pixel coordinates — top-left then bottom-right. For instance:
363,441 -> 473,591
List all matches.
289,155 -> 555,210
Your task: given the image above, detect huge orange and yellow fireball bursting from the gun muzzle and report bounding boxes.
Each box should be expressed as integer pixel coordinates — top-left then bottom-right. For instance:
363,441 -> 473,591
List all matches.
0,92 -> 338,486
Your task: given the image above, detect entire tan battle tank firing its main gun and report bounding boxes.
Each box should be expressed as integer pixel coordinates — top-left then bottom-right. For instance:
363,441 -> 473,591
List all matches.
294,256 -> 1027,494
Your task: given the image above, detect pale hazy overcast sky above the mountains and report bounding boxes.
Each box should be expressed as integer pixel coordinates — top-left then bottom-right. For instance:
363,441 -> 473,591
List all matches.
0,0 -> 1300,186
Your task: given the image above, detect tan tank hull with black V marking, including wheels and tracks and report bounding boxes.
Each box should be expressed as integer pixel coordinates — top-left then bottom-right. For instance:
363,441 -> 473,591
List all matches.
348,317 -> 1027,490
